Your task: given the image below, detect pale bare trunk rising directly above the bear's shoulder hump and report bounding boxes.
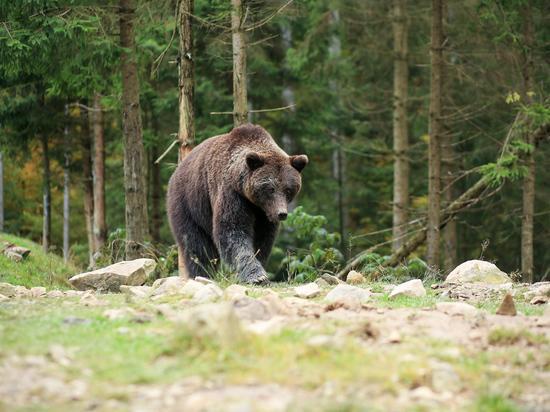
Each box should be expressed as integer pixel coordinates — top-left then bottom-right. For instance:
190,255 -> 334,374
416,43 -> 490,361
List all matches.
231,0 -> 248,127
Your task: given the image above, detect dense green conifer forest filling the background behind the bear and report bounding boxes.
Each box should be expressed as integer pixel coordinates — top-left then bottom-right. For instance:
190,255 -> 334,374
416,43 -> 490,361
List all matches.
0,0 -> 550,282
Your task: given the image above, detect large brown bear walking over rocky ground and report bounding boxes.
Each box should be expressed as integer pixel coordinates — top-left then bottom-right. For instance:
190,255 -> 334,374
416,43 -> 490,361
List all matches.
167,124 -> 308,283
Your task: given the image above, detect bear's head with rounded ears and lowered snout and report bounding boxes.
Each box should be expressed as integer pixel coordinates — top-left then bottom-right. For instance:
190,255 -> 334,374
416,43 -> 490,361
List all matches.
243,152 -> 308,223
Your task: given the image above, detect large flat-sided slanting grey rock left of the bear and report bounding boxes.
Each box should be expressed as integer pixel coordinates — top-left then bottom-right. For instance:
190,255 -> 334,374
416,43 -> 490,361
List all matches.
69,259 -> 156,292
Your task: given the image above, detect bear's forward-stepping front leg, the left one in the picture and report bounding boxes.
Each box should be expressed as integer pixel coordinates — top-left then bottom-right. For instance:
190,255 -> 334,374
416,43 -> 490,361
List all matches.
213,193 -> 268,284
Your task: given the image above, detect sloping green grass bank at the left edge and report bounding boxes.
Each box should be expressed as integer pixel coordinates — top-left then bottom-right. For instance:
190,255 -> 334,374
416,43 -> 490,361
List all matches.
0,234 -> 78,289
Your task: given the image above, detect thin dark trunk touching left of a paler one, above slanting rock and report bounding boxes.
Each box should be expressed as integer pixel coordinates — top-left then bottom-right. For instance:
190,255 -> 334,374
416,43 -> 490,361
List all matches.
80,114 -> 96,268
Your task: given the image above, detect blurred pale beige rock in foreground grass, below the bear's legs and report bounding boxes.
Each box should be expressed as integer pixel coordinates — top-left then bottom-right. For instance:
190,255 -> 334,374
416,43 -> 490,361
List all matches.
177,302 -> 243,344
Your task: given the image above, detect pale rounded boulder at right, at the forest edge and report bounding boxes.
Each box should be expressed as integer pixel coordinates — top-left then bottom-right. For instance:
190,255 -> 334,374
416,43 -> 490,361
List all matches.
445,260 -> 512,284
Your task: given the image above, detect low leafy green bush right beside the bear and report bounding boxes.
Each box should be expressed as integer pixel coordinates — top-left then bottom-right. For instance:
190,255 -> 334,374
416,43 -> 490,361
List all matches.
279,206 -> 343,282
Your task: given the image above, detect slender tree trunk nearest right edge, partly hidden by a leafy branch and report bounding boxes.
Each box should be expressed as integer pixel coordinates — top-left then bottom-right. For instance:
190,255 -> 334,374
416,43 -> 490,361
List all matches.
521,2 -> 536,283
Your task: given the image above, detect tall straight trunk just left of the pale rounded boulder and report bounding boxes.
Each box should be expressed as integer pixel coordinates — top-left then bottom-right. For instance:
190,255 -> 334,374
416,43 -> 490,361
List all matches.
427,0 -> 445,269
